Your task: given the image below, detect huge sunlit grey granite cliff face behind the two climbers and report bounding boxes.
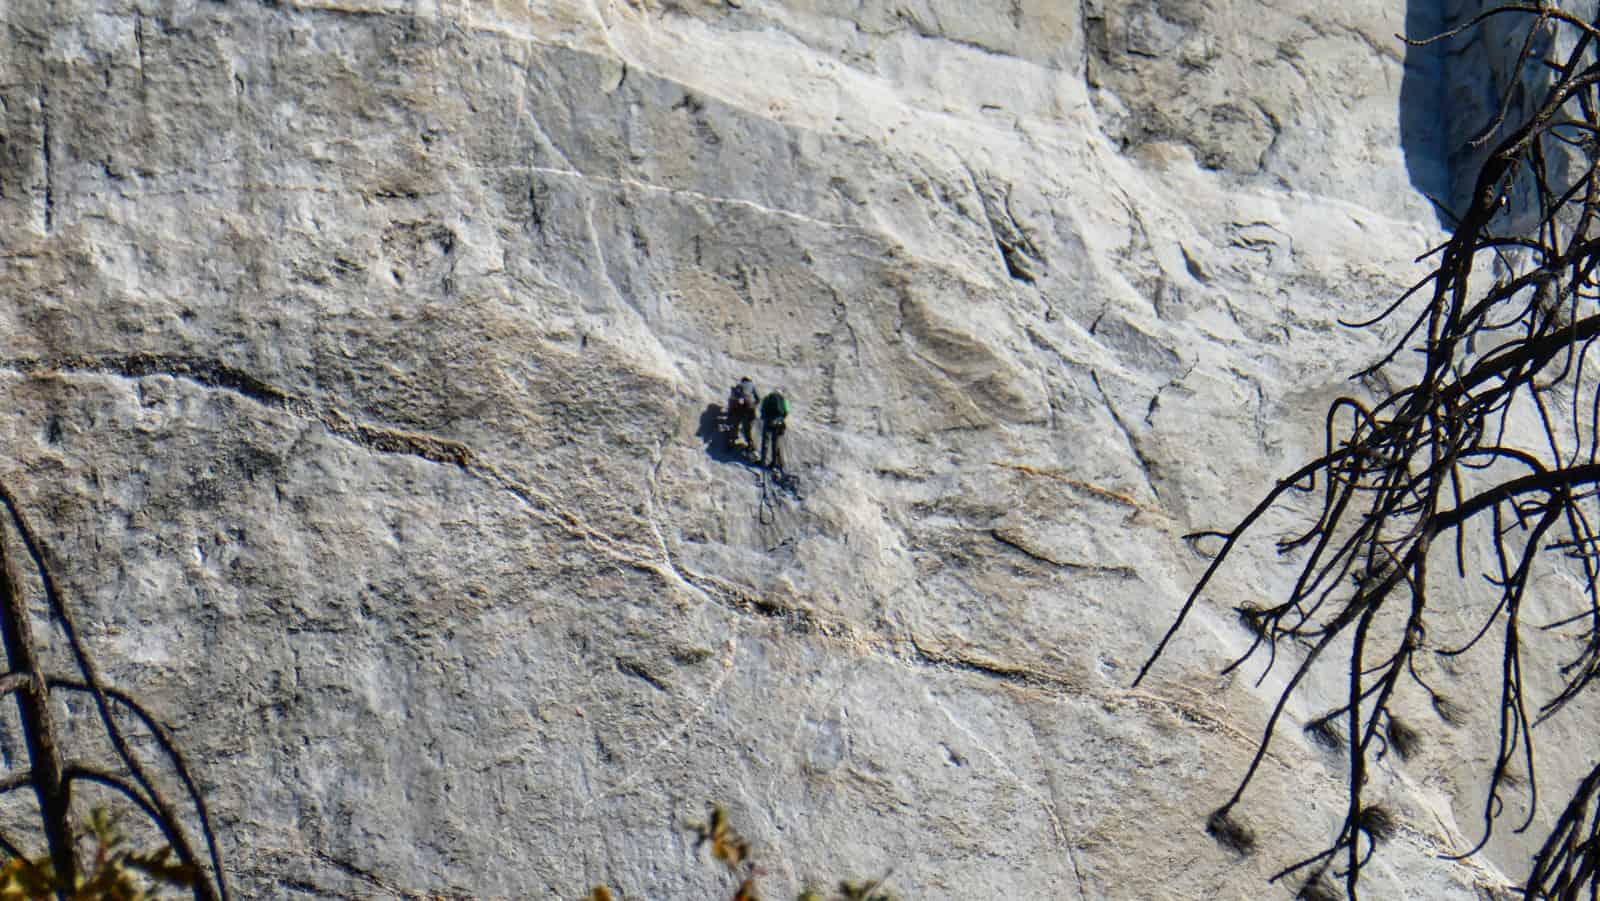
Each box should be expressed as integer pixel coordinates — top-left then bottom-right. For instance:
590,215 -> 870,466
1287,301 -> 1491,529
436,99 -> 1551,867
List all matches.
0,0 -> 1582,898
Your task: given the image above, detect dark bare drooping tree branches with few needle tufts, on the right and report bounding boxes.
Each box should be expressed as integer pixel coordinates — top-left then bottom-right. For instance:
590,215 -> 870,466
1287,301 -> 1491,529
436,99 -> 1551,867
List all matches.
1134,3 -> 1600,899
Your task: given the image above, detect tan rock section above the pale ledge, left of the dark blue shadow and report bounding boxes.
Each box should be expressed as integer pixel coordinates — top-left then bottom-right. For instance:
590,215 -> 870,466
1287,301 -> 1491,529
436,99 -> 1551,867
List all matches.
1083,0 -> 1438,218
